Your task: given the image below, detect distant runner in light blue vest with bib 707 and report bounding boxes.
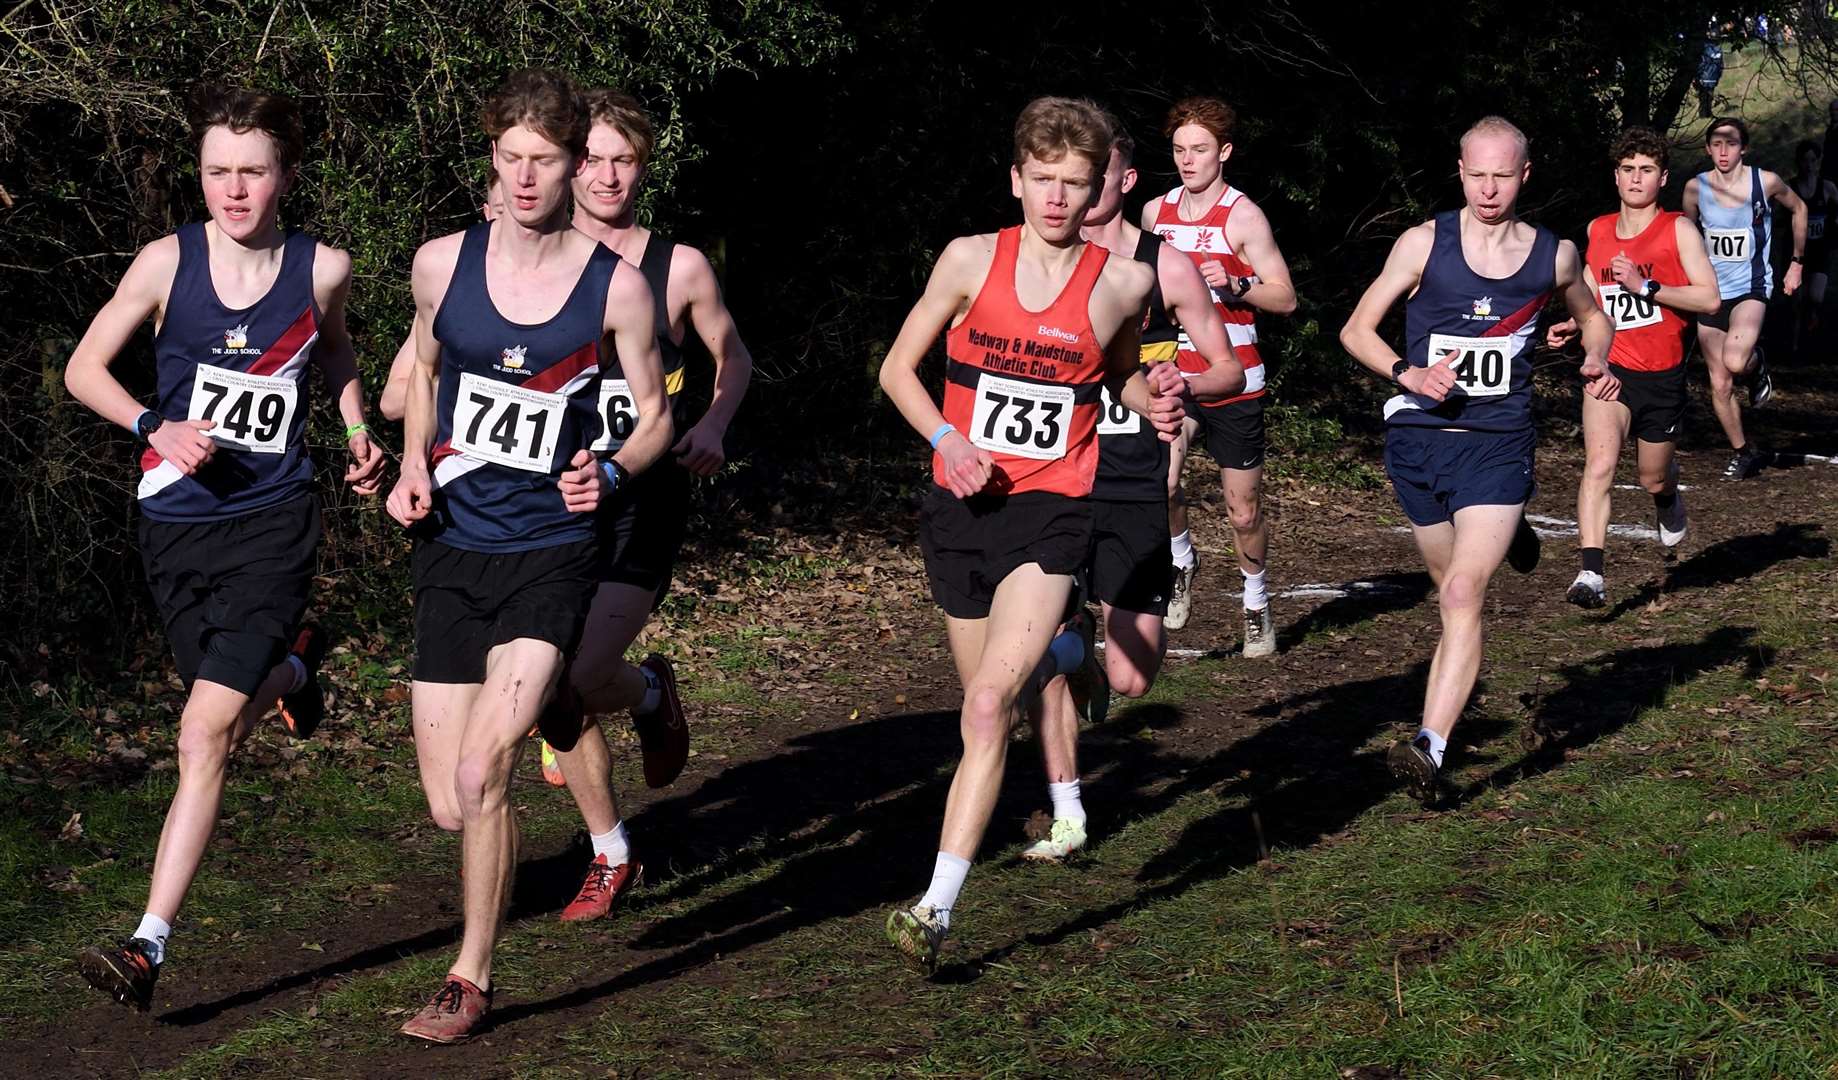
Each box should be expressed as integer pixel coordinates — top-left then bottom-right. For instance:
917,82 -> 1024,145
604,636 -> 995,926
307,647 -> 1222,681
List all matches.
1685,116 -> 1807,479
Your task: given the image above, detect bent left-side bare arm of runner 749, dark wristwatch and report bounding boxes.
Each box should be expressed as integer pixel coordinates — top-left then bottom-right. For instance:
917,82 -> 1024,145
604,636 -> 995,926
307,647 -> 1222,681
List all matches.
64,237 -> 217,476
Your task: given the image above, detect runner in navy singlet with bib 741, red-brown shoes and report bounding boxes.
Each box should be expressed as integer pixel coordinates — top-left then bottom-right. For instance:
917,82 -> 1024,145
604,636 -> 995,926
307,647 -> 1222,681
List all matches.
390,70 -> 671,1043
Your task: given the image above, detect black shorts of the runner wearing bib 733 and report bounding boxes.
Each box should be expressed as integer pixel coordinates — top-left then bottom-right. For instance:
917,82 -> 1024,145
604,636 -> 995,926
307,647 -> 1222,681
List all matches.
919,485 -> 1092,619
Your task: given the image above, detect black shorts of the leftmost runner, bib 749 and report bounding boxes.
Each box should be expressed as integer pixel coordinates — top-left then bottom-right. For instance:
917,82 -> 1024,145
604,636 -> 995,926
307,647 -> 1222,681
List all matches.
140,496 -> 320,696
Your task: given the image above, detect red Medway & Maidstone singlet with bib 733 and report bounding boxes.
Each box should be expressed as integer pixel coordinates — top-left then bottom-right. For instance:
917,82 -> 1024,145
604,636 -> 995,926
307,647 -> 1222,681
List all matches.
932,226 -> 1110,498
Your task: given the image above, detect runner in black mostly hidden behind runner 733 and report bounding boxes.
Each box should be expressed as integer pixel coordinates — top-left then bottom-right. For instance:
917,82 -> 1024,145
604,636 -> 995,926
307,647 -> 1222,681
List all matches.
1022,114 -> 1244,861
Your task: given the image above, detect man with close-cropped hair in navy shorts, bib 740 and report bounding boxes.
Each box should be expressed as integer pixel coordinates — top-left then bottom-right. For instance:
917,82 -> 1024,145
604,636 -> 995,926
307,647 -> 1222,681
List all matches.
1340,116 -> 1614,804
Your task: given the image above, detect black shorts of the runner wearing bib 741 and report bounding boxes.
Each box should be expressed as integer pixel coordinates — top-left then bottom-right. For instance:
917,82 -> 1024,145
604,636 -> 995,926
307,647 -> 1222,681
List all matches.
414,540 -> 599,683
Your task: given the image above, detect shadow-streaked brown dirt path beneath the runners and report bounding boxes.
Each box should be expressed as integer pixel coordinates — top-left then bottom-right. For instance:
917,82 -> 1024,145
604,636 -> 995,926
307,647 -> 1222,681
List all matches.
0,369 -> 1838,1076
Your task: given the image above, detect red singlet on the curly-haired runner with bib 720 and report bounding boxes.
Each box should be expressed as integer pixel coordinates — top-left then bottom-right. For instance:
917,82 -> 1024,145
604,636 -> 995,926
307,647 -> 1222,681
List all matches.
1584,209 -> 1691,371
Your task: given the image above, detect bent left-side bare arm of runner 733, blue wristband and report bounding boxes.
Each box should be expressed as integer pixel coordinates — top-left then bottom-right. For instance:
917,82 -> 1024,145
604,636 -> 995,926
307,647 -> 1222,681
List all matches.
880,235 -> 996,498
